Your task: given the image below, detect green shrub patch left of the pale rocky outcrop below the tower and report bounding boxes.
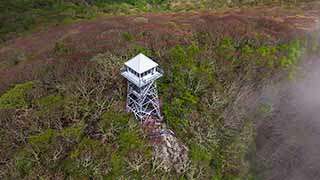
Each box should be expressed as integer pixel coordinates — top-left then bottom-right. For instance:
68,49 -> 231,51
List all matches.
99,110 -> 152,179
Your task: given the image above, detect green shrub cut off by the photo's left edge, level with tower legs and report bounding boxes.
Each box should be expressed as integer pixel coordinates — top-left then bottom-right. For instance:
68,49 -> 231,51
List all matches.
0,82 -> 34,109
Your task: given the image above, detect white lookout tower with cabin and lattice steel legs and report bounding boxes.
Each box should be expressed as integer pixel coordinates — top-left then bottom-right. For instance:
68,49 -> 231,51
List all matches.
121,53 -> 163,121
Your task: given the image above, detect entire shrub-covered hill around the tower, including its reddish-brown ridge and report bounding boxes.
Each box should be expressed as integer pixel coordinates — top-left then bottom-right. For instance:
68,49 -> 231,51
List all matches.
0,1 -> 320,180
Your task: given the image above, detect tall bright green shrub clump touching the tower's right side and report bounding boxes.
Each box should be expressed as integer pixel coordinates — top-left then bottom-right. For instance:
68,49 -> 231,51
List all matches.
160,45 -> 204,136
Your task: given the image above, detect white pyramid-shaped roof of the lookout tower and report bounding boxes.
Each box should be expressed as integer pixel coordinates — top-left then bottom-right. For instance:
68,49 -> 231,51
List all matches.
124,53 -> 158,74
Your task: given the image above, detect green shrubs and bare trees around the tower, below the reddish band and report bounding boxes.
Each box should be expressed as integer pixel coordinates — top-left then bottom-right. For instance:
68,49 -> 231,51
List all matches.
0,35 -> 304,179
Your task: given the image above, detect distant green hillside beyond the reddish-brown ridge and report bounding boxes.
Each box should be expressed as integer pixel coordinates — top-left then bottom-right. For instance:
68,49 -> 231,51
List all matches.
0,0 -> 311,42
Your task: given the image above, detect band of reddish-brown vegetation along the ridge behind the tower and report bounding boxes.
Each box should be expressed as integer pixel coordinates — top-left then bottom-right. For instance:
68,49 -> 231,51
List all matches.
0,4 -> 320,92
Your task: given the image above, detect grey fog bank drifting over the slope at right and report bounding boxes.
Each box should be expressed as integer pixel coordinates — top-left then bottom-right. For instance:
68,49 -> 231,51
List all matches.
256,59 -> 320,180
